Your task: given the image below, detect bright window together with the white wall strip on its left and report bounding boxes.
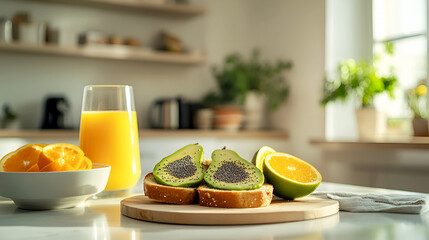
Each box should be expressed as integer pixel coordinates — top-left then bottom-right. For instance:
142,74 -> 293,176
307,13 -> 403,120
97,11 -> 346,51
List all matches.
325,0 -> 428,139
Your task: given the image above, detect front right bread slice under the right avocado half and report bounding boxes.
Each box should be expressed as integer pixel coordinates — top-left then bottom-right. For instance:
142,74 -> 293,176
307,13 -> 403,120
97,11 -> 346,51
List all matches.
198,183 -> 273,208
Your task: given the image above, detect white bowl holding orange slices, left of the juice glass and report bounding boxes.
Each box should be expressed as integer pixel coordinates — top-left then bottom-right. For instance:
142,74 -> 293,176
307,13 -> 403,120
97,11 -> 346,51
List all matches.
0,163 -> 110,210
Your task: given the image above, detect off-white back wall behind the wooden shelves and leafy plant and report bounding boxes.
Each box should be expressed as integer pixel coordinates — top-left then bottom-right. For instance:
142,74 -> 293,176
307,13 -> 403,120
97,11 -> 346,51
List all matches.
0,0 -> 325,166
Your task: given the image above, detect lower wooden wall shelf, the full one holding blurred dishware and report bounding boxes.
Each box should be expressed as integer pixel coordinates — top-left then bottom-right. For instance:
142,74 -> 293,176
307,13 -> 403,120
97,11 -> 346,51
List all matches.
0,43 -> 205,65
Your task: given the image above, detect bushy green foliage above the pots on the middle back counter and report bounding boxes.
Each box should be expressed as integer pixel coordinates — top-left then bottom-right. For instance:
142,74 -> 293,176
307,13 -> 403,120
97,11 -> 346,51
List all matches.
203,49 -> 292,110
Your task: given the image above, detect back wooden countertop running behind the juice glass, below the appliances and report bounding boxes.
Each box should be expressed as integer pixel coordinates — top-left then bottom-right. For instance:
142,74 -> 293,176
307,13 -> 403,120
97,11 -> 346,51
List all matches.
0,129 -> 289,140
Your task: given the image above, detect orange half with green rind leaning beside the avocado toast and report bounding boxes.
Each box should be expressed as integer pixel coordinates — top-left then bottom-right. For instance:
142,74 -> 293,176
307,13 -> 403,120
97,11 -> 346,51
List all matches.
264,152 -> 322,199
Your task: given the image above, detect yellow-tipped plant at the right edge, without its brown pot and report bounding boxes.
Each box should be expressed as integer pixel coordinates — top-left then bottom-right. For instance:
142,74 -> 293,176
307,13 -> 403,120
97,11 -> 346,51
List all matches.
407,83 -> 428,118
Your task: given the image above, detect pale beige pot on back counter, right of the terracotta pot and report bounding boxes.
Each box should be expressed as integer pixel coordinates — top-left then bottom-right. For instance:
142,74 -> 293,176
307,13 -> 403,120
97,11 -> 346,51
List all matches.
244,91 -> 267,130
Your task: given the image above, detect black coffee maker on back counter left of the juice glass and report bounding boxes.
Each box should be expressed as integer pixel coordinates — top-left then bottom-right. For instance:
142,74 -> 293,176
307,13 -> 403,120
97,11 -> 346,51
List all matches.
41,96 -> 70,129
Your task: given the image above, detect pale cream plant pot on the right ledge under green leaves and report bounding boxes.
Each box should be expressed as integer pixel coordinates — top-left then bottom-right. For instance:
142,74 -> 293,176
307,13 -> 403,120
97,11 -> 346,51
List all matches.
356,108 -> 387,139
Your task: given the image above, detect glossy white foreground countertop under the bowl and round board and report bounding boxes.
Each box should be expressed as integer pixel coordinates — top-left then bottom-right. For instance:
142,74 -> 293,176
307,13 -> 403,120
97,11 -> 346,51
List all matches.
0,182 -> 429,240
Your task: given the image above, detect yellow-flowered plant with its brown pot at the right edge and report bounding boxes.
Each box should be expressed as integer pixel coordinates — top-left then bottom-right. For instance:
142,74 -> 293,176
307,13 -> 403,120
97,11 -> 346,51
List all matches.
407,83 -> 429,136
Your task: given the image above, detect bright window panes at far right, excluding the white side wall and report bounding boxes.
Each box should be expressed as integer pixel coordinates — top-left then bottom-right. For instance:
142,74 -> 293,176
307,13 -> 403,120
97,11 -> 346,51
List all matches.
373,0 -> 427,118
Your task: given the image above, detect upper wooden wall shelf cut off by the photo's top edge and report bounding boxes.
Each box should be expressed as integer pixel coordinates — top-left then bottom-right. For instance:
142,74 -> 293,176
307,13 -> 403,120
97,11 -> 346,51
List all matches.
32,0 -> 206,16
